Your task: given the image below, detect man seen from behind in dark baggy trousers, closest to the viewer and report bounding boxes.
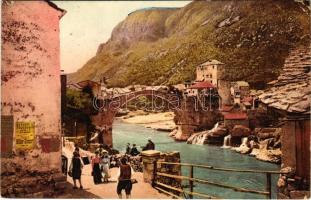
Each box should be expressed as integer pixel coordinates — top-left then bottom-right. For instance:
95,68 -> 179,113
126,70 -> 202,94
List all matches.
117,157 -> 132,199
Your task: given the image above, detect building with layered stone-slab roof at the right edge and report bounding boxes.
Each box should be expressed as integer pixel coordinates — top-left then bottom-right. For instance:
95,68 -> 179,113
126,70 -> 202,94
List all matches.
259,47 -> 311,199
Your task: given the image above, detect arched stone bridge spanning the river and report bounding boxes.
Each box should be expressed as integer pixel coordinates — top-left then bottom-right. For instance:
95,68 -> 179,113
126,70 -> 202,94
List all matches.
92,87 -> 222,146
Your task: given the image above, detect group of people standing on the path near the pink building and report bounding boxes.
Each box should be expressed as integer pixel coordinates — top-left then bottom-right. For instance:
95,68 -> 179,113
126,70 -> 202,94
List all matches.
69,146 -> 133,198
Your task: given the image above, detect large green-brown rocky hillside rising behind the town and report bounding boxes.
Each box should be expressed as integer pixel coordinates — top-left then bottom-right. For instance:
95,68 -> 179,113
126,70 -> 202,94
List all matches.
69,0 -> 310,87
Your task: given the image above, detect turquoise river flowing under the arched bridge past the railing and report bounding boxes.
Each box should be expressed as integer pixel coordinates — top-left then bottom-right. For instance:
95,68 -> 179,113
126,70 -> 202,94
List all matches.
112,120 -> 280,199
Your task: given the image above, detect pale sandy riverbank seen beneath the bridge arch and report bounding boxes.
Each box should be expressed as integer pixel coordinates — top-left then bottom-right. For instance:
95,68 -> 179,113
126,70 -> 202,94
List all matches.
118,110 -> 176,132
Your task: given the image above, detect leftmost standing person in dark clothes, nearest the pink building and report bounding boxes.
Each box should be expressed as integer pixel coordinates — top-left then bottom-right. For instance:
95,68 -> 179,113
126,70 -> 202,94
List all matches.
69,151 -> 83,189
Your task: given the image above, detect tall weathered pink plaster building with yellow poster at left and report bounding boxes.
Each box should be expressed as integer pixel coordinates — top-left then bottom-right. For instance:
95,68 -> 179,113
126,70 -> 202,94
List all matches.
1,1 -> 66,198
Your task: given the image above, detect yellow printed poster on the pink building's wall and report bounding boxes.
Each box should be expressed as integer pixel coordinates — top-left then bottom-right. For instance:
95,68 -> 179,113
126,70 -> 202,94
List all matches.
15,122 -> 35,150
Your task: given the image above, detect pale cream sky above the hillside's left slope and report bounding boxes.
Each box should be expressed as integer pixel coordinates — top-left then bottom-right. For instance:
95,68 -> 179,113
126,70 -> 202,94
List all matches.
53,1 -> 190,73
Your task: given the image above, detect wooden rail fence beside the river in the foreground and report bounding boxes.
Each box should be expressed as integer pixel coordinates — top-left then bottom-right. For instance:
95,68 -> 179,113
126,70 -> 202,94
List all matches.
153,161 -> 281,199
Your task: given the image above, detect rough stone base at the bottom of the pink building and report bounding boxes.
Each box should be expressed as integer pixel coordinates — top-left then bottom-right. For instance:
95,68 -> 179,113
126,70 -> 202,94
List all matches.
1,159 -> 67,198
